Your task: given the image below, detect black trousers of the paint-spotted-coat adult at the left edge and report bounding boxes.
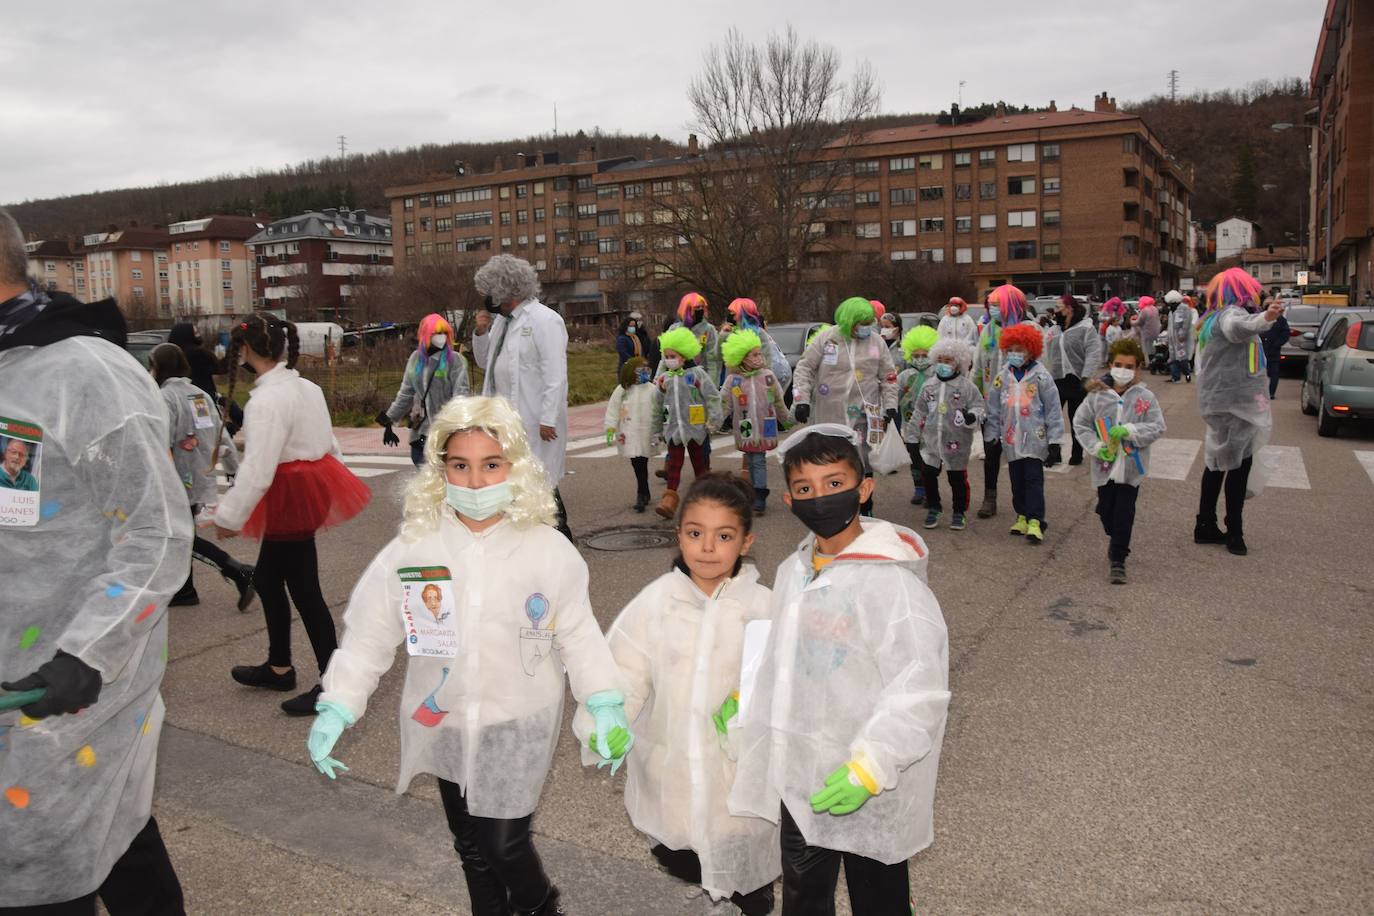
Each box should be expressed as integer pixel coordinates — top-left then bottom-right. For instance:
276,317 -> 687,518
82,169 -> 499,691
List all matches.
0,817 -> 185,916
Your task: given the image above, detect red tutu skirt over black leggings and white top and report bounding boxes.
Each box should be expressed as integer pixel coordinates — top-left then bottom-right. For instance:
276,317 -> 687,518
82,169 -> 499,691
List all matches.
243,455 -> 372,541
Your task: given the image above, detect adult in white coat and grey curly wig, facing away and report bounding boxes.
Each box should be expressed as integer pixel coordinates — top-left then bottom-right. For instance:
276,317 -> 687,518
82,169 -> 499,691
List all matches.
473,254 -> 573,540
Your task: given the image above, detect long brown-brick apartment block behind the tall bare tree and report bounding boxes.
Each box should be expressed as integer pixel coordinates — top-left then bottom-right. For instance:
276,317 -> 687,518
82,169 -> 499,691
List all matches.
386,93 -> 1193,320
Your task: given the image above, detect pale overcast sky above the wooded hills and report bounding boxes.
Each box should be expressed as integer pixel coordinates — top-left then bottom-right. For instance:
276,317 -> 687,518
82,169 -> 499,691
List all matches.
0,0 -> 1326,202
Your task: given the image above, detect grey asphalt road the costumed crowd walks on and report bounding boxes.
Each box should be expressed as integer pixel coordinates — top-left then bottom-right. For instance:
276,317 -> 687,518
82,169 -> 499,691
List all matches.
157,379 -> 1374,915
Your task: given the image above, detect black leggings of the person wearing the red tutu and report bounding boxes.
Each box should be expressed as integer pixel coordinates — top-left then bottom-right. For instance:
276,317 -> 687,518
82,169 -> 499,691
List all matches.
253,537 -> 338,674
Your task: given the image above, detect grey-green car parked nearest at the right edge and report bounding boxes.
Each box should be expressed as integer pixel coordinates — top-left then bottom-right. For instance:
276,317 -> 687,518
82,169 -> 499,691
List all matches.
1298,308 -> 1374,435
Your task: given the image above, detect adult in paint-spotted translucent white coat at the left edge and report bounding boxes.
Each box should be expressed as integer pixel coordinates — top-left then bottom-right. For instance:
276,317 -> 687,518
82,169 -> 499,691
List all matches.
0,210 -> 191,913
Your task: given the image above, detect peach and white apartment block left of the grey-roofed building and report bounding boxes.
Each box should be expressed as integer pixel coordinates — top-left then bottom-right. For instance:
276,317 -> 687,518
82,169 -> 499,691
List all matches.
167,216 -> 264,317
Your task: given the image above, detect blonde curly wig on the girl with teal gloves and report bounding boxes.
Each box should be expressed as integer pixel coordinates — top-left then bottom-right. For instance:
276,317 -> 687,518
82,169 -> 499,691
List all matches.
401,397 -> 554,541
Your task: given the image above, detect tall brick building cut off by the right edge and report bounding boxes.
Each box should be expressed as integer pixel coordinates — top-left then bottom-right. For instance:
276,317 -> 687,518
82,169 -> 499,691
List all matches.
1308,0 -> 1374,301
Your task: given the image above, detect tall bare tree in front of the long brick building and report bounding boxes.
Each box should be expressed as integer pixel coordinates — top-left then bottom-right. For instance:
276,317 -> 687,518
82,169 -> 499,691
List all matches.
627,27 -> 879,320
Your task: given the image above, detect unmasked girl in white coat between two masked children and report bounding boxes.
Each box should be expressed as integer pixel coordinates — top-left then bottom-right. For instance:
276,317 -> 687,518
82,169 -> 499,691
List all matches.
574,474 -> 782,916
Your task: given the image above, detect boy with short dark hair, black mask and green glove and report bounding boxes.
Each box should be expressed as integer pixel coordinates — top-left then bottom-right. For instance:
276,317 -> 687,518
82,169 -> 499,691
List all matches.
730,423 -> 949,916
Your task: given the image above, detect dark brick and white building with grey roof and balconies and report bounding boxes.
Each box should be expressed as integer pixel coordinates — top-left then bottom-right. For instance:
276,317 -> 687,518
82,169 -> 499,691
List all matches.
246,207 -> 392,323
